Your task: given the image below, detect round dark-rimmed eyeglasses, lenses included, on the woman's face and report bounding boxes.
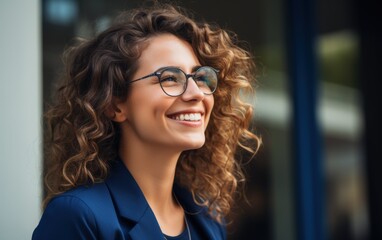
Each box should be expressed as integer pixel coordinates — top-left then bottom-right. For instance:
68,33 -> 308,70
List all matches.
130,66 -> 219,97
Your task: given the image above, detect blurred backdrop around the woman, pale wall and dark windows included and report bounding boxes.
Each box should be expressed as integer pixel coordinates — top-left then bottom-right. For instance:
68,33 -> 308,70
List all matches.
0,0 -> 382,240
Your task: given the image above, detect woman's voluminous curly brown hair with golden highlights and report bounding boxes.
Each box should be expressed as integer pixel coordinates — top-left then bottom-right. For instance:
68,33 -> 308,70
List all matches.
44,4 -> 261,221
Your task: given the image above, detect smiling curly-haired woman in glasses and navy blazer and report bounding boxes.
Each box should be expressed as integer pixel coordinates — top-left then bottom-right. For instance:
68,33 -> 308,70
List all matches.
32,4 -> 259,240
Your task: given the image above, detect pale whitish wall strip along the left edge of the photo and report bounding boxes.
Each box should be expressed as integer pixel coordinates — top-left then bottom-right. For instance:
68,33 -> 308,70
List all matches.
0,0 -> 42,240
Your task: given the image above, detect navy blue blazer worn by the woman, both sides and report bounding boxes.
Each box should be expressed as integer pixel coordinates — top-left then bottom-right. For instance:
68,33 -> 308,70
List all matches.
32,161 -> 226,240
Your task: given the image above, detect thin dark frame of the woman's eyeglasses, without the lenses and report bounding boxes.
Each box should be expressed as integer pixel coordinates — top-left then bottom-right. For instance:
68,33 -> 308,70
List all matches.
129,66 -> 219,97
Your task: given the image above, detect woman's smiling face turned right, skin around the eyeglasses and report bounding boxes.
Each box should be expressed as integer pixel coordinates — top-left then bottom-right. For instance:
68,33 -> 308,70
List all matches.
120,34 -> 214,152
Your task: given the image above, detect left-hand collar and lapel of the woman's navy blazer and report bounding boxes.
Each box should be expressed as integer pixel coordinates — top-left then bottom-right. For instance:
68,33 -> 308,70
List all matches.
105,160 -> 163,240
